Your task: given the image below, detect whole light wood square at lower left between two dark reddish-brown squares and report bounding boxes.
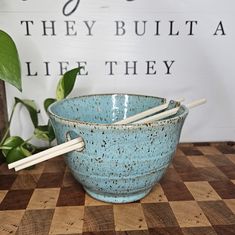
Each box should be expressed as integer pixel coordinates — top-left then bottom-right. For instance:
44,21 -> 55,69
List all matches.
27,188 -> 60,209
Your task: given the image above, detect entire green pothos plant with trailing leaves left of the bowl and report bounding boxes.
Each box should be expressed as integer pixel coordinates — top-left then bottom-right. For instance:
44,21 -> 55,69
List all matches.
0,30 -> 81,163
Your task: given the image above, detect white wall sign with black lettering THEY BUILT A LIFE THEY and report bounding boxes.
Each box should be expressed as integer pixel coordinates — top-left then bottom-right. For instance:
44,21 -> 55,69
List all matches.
0,0 -> 235,141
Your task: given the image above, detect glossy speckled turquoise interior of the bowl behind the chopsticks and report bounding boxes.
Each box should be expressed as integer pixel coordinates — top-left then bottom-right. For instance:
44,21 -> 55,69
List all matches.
49,94 -> 183,124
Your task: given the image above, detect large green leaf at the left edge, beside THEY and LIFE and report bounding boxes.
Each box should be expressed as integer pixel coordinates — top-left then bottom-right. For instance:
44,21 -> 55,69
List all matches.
0,30 -> 22,91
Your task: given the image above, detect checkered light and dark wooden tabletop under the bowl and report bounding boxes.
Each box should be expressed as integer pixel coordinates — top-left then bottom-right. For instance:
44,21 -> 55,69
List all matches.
0,143 -> 235,235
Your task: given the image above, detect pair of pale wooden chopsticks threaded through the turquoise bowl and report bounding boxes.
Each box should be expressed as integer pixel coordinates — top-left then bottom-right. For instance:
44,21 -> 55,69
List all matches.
8,98 -> 206,171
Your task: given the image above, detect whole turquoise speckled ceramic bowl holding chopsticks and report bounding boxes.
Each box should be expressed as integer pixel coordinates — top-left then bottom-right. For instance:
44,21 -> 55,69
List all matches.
49,94 -> 188,203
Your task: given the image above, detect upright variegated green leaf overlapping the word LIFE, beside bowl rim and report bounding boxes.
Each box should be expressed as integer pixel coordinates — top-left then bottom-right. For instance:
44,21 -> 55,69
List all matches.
56,67 -> 83,100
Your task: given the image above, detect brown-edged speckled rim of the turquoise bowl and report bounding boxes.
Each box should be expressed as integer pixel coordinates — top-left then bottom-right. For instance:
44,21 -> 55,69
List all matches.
47,93 -> 189,129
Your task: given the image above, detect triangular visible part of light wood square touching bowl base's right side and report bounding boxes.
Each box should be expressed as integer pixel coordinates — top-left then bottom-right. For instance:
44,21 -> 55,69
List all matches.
141,184 -> 168,203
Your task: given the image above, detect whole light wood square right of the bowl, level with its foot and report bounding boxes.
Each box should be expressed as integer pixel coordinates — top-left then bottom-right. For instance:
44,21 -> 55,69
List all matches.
185,181 -> 221,201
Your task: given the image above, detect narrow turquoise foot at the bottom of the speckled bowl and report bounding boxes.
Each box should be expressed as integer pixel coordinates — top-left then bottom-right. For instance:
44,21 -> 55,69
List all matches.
84,187 -> 152,203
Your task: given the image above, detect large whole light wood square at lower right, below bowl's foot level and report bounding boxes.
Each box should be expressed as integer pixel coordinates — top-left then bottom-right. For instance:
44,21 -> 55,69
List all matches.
170,201 -> 211,227
